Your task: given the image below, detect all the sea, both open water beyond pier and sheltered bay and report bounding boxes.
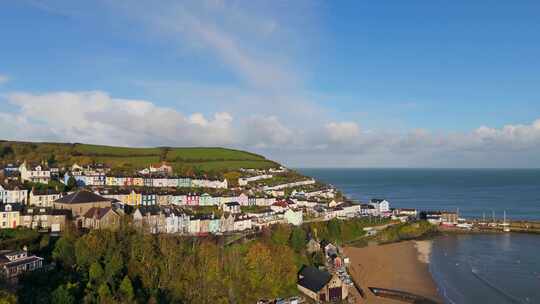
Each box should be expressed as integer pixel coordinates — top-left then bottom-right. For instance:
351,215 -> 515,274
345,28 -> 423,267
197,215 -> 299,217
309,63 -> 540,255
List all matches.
297,168 -> 540,304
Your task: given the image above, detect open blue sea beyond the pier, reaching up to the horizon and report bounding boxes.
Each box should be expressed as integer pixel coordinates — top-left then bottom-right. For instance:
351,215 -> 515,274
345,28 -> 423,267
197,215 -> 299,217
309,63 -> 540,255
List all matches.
299,169 -> 540,220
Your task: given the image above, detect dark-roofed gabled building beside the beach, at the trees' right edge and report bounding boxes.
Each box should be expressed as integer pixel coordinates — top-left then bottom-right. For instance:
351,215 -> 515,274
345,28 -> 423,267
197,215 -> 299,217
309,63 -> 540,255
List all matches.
297,266 -> 348,302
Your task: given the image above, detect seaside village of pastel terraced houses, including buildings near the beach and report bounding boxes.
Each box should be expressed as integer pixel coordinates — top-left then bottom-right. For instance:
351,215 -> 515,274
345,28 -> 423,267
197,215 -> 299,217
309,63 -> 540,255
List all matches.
0,162 -> 472,303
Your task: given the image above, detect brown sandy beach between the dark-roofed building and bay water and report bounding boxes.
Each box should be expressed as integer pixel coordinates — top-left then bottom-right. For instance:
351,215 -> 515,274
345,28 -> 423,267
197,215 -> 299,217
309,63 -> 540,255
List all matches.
344,241 -> 442,304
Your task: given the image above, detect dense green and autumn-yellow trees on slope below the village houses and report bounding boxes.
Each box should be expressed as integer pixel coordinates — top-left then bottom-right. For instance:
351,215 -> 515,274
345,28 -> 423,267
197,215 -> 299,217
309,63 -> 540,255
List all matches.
5,226 -> 310,303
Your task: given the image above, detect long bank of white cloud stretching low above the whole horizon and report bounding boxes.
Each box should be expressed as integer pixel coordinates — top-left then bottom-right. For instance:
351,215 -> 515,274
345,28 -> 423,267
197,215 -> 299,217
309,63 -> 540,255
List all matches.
0,91 -> 540,167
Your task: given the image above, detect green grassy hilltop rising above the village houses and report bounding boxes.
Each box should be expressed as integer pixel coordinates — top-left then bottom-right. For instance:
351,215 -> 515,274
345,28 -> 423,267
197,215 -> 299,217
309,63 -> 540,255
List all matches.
0,141 -> 279,174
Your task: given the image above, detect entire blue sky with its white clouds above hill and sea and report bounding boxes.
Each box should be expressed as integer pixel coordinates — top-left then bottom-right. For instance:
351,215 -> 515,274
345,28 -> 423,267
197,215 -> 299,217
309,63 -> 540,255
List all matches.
0,0 -> 540,167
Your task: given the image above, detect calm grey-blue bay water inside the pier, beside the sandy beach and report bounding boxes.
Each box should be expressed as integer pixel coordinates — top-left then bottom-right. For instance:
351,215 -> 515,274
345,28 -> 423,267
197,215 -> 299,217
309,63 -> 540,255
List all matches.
430,233 -> 540,303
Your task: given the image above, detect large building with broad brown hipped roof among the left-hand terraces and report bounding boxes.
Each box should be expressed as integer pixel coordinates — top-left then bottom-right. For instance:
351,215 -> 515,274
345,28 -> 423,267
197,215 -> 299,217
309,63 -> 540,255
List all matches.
53,190 -> 111,217
